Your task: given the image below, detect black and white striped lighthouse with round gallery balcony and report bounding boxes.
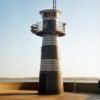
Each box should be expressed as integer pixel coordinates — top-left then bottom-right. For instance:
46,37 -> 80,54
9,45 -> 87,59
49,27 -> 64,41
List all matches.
31,9 -> 65,94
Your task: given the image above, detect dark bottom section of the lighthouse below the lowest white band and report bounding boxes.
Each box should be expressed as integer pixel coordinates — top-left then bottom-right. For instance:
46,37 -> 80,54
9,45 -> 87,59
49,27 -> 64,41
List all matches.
38,71 -> 63,95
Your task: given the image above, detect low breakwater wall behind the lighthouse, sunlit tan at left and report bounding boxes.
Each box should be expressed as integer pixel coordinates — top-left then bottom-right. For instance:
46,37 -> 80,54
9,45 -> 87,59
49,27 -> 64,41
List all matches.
0,82 -> 100,93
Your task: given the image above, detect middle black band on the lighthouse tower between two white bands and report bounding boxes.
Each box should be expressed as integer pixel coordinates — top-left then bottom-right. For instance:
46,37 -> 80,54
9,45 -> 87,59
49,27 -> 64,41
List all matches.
41,45 -> 59,59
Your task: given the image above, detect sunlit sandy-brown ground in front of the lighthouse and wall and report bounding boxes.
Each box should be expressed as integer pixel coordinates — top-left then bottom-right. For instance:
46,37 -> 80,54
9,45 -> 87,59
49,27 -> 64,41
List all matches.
0,90 -> 100,100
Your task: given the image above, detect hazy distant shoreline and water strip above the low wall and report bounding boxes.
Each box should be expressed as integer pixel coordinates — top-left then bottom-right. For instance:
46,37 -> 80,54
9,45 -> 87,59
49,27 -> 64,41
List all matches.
0,77 -> 100,83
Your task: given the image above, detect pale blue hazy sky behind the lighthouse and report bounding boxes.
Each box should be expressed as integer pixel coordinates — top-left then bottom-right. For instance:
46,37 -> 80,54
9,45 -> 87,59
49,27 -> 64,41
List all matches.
0,0 -> 100,77
